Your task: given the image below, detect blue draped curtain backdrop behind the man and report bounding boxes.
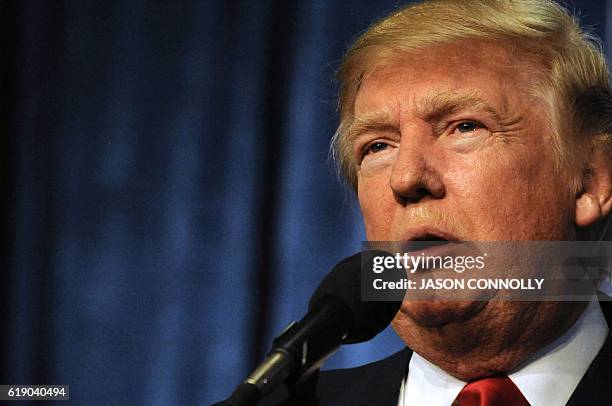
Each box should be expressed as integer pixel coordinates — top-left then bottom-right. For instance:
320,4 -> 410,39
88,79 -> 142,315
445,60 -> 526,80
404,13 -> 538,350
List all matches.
0,0 -> 606,405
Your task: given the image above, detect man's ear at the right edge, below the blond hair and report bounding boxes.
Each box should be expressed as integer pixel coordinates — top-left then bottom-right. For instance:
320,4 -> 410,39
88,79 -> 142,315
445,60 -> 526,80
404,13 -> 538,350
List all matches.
576,146 -> 612,228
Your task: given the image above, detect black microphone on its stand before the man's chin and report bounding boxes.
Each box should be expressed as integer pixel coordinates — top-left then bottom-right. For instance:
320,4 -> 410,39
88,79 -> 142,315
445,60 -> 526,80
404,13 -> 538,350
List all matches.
226,251 -> 401,406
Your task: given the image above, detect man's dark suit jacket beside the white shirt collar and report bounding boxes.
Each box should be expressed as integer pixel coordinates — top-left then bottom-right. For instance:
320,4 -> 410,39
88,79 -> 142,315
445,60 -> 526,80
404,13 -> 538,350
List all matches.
317,302 -> 612,406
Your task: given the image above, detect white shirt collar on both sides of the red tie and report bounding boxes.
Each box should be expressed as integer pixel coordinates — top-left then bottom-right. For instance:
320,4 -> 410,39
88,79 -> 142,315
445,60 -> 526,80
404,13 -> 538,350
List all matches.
398,299 -> 608,406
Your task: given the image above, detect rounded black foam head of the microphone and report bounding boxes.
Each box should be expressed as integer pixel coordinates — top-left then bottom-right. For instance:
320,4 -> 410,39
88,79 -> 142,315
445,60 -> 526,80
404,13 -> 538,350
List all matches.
308,250 -> 402,344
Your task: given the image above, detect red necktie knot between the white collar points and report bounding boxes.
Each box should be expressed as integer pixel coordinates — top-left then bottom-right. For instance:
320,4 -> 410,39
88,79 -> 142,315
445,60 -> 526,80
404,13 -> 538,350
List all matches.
453,375 -> 530,406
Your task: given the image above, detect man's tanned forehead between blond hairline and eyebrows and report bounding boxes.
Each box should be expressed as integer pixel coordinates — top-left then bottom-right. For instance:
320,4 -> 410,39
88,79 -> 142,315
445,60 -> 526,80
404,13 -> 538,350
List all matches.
354,41 -> 537,119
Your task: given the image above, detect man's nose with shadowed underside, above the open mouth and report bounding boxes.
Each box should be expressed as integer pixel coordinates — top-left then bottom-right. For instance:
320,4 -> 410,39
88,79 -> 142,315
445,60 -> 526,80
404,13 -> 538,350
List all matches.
389,123 -> 445,205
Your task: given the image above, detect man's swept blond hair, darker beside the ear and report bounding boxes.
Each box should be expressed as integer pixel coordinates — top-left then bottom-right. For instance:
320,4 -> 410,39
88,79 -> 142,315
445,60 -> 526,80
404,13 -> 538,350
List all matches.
331,0 -> 612,196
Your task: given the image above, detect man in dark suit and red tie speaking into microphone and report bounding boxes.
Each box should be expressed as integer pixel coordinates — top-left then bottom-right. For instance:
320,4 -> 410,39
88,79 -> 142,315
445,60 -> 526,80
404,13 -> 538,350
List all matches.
319,0 -> 612,406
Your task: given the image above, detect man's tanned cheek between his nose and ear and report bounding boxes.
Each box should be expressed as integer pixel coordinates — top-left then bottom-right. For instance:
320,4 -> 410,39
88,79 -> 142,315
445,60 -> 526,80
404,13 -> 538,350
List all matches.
447,145 -> 570,240
